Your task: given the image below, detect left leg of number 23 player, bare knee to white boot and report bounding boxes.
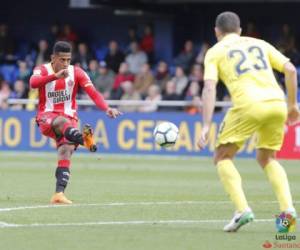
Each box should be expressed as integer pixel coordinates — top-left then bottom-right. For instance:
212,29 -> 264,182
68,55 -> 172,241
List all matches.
215,144 -> 254,232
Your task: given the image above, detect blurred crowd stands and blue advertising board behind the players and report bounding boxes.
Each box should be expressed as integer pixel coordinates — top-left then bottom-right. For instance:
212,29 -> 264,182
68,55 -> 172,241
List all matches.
0,0 -> 300,158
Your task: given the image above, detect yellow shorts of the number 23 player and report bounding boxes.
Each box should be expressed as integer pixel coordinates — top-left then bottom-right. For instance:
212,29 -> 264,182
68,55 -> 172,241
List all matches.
216,101 -> 287,151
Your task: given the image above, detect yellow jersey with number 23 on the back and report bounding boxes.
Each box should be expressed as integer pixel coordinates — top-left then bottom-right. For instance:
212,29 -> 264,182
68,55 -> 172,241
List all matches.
204,33 -> 289,106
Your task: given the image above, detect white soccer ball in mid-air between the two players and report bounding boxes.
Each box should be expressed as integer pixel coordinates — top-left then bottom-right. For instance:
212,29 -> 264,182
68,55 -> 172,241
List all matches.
153,122 -> 178,147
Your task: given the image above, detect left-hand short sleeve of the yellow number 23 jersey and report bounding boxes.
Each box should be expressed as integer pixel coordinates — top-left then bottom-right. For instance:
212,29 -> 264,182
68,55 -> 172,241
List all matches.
204,49 -> 219,81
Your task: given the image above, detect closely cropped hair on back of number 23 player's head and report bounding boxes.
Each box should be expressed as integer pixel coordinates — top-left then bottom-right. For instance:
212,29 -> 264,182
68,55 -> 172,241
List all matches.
216,11 -> 241,33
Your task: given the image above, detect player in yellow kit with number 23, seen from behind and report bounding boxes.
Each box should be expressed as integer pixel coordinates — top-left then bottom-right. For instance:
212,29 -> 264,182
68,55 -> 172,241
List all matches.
198,12 -> 299,232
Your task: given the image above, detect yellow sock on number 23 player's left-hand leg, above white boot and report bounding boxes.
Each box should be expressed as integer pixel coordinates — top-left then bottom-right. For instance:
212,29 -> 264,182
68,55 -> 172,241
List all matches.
217,160 -> 248,212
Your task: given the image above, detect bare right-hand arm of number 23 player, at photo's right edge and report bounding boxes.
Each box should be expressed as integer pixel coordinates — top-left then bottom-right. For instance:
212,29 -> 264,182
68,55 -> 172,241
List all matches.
283,62 -> 300,124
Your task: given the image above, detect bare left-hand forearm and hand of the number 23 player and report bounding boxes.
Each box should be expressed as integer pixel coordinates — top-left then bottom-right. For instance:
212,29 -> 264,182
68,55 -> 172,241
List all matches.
198,80 -> 217,149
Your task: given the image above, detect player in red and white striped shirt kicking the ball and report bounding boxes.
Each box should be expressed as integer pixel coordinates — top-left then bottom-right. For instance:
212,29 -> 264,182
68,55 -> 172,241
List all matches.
30,41 -> 120,204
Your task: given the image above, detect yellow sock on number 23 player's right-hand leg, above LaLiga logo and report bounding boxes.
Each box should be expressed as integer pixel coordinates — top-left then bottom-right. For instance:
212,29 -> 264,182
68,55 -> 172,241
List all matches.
264,161 -> 293,211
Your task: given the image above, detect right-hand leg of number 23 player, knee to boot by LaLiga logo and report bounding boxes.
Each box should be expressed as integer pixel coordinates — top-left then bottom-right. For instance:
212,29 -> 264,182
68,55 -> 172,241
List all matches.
257,149 -> 297,232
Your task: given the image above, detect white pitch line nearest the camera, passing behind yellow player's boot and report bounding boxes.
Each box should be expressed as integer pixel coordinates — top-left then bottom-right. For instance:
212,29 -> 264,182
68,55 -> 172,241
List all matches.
0,219 -> 284,228
